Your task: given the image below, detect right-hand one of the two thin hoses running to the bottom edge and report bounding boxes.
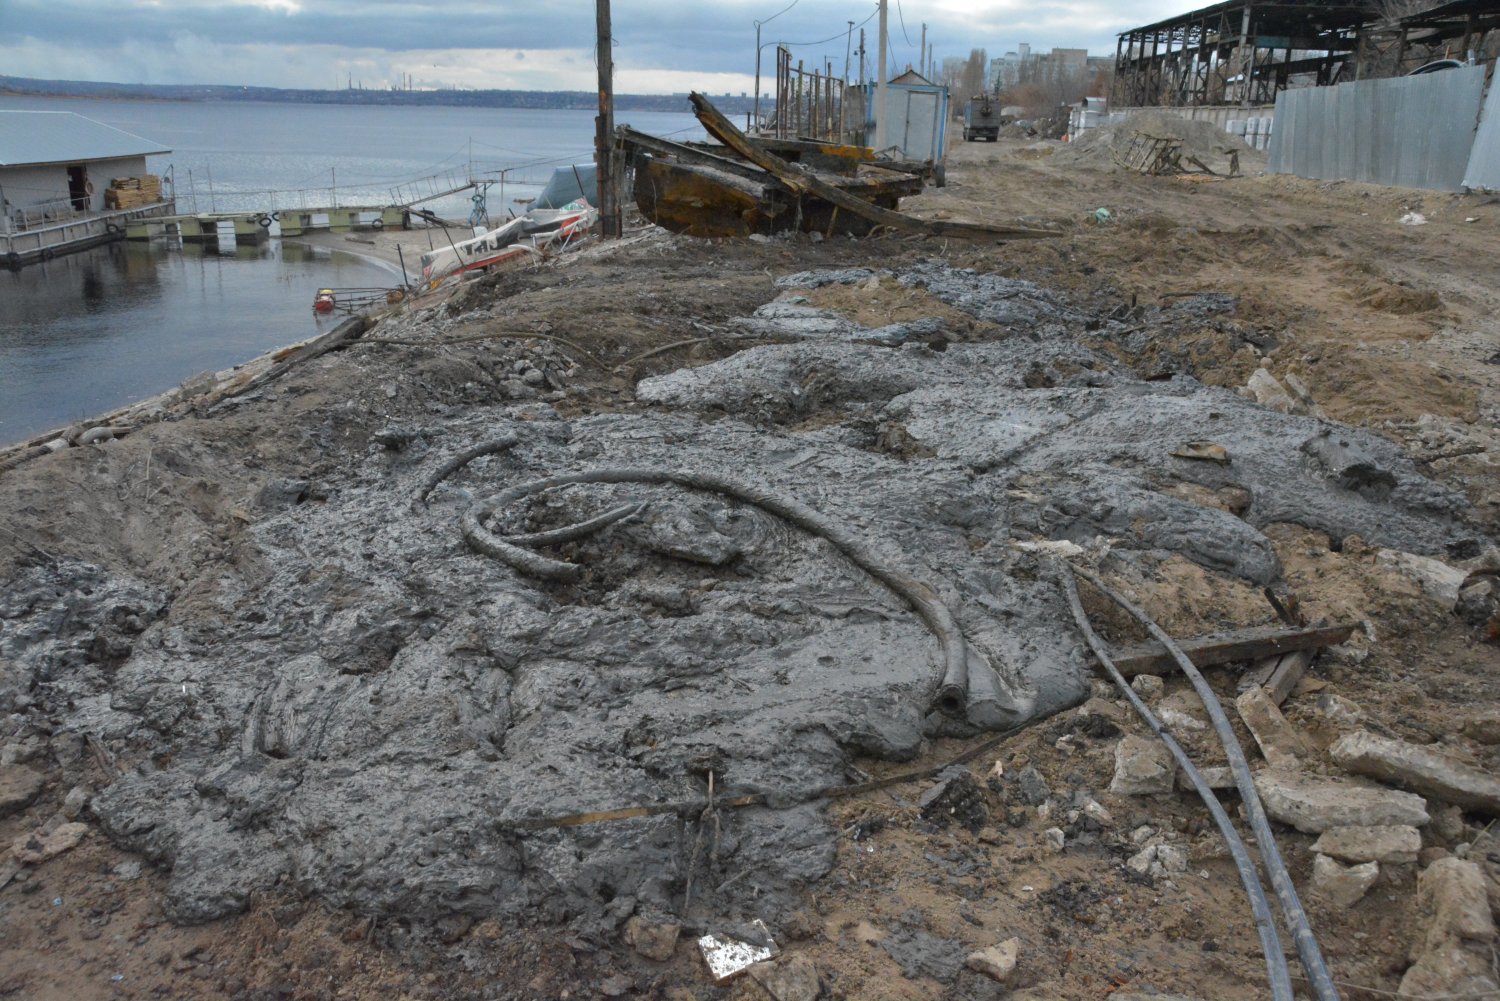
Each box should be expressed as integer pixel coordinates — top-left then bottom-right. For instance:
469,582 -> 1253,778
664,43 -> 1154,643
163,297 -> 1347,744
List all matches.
1073,567 -> 1338,1001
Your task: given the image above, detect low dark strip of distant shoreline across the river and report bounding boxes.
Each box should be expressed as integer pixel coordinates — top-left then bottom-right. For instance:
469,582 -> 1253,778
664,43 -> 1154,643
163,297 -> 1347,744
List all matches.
0,77 -> 753,116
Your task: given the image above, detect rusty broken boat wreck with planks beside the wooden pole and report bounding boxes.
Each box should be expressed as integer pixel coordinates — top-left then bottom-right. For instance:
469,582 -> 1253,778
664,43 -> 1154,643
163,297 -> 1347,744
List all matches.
615,93 -> 1058,239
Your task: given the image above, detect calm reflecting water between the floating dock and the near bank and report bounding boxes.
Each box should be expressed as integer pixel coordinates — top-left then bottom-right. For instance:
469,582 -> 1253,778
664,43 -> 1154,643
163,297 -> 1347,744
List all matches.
0,240 -> 392,443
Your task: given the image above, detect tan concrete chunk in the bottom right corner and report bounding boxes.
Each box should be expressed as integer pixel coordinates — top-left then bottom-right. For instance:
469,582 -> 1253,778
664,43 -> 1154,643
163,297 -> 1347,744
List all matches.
1400,858 -> 1500,998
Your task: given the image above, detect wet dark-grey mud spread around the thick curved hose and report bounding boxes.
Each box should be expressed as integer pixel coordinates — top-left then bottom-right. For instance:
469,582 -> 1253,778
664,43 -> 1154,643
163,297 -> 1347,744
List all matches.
0,264 -> 1476,936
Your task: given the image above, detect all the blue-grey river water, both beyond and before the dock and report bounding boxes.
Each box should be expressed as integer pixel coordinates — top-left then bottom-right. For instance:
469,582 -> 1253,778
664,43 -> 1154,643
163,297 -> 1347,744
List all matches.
0,96 -> 702,444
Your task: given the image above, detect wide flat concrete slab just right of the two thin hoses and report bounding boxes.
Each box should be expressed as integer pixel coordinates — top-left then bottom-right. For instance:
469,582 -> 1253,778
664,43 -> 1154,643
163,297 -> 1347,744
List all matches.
1256,770 -> 1430,834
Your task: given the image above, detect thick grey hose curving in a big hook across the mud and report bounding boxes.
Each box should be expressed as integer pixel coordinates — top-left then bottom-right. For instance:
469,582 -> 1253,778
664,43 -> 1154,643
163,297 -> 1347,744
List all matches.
459,465 -> 969,716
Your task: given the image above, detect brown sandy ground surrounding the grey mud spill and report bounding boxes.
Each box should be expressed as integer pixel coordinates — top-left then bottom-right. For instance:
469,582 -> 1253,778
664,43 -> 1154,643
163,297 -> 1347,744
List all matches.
0,131 -> 1500,1001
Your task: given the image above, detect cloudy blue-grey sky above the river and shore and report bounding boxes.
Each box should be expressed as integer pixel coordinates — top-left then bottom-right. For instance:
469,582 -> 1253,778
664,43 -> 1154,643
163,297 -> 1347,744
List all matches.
0,0 -> 1170,93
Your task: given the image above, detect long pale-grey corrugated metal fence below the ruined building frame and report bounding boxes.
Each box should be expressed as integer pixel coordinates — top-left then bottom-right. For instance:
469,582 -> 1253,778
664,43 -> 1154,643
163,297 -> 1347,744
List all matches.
1271,66 -> 1500,191
